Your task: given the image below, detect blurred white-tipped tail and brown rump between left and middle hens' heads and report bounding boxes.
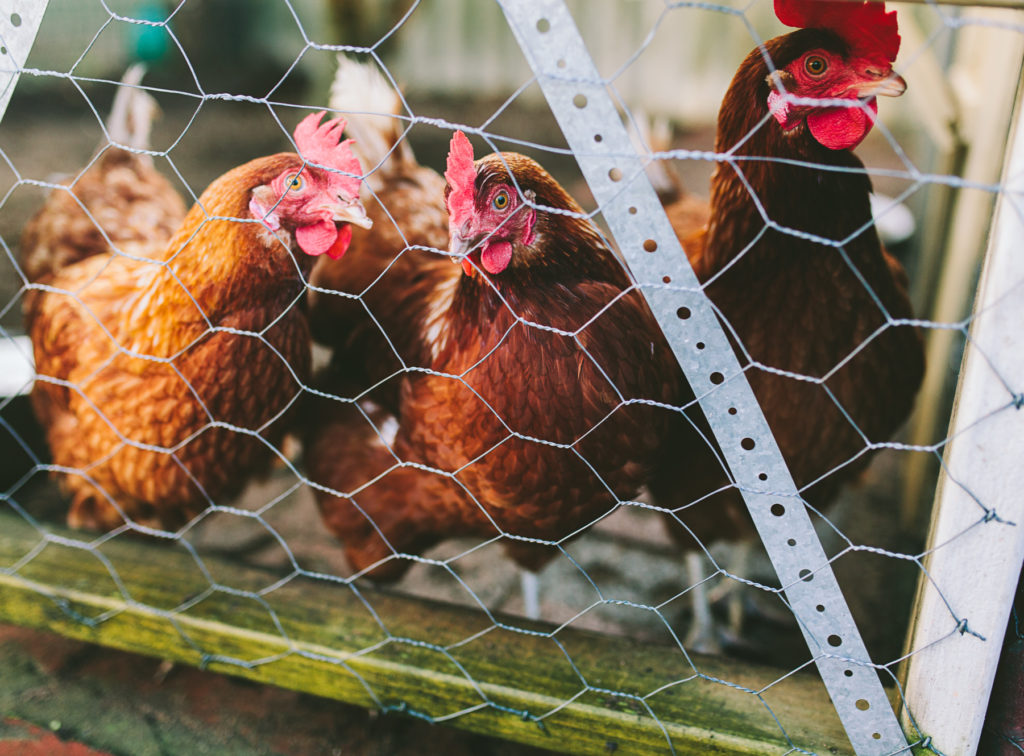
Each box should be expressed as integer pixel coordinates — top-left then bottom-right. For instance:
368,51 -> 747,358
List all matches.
309,55 -> 448,401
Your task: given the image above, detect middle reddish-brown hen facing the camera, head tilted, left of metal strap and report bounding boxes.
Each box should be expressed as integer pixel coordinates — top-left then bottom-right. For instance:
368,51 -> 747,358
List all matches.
306,132 -> 685,579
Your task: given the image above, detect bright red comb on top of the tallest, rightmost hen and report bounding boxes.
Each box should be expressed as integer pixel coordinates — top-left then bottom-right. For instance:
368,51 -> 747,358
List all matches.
775,0 -> 900,62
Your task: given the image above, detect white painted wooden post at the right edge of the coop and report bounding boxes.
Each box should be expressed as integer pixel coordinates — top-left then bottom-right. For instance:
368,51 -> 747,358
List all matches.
903,70 -> 1024,756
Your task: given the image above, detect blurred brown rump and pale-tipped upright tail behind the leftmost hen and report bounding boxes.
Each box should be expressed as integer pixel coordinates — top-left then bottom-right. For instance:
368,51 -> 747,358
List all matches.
22,65 -> 186,282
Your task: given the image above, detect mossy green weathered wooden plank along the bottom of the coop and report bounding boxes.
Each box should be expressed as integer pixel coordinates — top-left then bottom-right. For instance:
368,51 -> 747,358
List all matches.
0,509 -> 864,754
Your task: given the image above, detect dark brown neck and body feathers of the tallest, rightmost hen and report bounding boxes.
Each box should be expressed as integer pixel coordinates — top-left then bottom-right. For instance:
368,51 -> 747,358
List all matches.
651,30 -> 924,543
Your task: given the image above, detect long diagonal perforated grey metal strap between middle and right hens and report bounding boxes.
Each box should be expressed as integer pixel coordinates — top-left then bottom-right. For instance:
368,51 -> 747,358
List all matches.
498,0 -> 908,756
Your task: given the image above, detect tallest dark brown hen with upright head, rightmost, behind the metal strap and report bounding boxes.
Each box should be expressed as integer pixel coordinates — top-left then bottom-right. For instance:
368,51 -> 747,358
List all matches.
650,0 -> 924,643
